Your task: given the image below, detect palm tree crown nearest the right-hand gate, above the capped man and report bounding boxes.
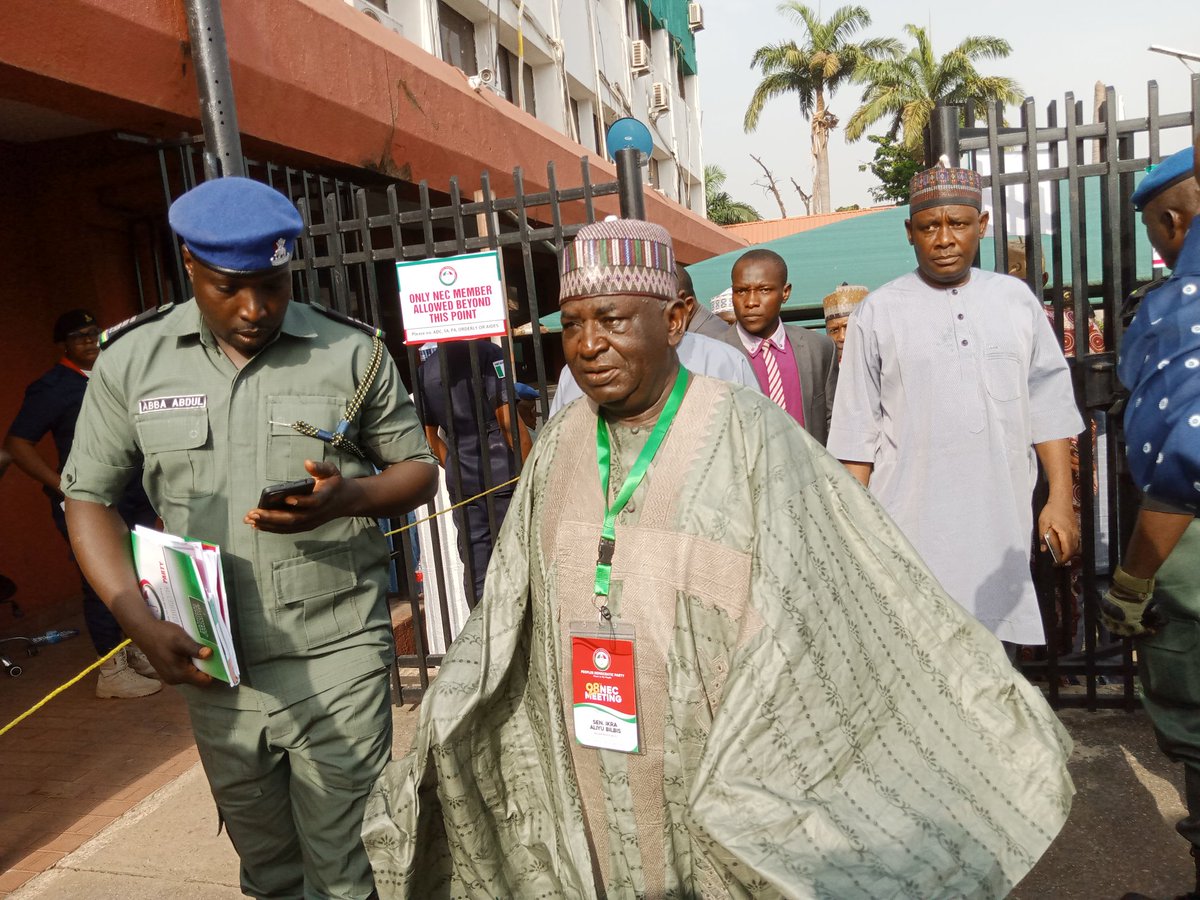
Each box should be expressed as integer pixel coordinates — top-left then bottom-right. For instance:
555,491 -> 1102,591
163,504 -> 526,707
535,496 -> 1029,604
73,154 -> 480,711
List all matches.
846,25 -> 1022,151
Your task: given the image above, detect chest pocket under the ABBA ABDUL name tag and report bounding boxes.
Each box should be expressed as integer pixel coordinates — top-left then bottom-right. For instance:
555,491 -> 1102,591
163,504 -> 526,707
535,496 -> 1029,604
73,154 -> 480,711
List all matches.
134,409 -> 212,499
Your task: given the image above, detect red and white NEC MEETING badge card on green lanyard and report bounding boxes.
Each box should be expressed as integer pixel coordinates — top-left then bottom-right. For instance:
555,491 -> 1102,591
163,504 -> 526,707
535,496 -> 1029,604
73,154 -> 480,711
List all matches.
570,620 -> 638,754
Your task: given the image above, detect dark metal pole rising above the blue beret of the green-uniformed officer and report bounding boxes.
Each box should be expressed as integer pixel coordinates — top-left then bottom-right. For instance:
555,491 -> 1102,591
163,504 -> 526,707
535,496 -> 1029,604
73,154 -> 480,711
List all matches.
185,0 -> 246,179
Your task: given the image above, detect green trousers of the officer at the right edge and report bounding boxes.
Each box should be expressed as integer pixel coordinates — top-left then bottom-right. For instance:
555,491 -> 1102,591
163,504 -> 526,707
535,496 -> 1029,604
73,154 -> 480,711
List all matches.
1138,521 -> 1200,846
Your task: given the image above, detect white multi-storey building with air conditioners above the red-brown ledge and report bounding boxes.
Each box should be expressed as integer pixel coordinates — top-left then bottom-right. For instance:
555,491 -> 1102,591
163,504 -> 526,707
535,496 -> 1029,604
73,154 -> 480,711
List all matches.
346,0 -> 704,212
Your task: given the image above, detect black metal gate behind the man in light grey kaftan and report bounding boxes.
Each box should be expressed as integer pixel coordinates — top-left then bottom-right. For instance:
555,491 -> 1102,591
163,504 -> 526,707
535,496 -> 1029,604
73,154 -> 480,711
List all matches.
926,76 -> 1200,709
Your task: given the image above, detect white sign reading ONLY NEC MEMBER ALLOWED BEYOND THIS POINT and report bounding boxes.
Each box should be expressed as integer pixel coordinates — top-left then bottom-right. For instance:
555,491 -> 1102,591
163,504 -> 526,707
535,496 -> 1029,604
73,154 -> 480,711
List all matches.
396,251 -> 508,343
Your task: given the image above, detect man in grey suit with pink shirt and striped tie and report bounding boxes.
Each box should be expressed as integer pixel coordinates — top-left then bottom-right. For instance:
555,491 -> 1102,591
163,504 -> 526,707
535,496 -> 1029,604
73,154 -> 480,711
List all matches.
725,250 -> 838,445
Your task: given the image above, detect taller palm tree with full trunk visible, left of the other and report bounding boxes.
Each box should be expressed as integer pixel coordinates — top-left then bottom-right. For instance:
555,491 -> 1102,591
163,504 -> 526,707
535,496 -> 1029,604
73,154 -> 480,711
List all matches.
744,0 -> 901,212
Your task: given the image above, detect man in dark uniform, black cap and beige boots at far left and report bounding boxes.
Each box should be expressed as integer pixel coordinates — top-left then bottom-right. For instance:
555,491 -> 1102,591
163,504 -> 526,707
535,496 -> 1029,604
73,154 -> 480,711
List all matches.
5,310 -> 162,700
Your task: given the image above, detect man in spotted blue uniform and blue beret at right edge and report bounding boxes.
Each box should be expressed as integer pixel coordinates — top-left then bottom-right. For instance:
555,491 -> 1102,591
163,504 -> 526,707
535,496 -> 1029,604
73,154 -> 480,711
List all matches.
1100,148 -> 1200,900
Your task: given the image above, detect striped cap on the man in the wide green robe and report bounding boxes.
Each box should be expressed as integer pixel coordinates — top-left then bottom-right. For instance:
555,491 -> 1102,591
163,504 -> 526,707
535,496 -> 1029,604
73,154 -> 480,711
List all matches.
558,218 -> 679,304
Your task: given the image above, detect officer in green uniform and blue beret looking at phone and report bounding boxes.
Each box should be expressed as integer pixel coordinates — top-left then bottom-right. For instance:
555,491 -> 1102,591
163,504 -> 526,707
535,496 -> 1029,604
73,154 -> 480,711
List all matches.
62,178 -> 437,898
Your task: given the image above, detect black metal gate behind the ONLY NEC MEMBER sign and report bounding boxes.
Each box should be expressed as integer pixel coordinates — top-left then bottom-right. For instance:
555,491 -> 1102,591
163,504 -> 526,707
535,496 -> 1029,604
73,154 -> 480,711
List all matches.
133,136 -> 619,697
